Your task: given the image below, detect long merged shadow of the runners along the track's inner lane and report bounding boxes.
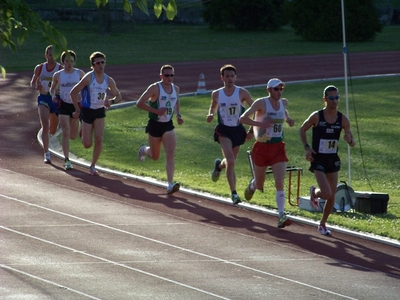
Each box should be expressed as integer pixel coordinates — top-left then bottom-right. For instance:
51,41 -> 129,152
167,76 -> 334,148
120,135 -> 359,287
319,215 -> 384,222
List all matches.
53,164 -> 400,278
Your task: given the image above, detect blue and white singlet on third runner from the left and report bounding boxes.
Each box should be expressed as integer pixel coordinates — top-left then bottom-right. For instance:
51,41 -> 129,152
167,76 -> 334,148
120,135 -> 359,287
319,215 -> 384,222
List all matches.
81,71 -> 108,109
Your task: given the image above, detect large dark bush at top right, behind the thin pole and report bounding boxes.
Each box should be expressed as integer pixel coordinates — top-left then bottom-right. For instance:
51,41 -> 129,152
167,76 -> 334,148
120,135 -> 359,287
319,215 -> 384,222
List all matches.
286,0 -> 383,42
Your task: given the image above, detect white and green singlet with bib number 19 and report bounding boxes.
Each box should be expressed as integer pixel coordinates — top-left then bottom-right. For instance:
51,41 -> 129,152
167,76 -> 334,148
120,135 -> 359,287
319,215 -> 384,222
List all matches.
149,82 -> 178,123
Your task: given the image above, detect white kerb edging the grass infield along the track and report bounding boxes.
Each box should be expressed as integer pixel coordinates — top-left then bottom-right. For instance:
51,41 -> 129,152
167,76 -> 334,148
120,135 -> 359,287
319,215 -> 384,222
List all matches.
37,77 -> 400,248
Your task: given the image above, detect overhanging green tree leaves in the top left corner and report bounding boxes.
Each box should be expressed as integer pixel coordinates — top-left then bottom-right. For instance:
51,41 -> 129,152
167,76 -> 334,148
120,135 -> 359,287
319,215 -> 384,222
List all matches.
0,0 -> 178,78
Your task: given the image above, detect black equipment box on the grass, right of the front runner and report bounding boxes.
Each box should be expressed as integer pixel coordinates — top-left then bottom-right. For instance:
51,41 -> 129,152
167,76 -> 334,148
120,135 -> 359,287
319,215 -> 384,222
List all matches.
354,191 -> 389,215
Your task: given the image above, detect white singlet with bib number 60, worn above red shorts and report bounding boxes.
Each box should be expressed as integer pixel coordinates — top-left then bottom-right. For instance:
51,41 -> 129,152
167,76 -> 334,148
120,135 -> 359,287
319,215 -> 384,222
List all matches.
253,97 -> 285,143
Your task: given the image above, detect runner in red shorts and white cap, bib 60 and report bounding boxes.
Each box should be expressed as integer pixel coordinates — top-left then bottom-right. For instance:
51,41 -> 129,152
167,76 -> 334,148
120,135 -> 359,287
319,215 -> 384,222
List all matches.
240,78 -> 294,228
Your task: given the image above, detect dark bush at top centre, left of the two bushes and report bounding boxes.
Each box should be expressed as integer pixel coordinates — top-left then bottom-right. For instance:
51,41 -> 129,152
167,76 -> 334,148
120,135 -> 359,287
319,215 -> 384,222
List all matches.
203,0 -> 284,31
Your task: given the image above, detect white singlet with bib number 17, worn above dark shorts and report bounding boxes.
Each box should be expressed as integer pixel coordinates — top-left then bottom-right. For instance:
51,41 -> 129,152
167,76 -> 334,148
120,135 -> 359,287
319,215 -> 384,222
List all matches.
217,86 -> 245,127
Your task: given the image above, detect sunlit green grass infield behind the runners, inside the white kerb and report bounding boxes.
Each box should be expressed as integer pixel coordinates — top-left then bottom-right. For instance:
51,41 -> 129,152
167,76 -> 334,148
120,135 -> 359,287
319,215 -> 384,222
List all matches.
71,77 -> 400,240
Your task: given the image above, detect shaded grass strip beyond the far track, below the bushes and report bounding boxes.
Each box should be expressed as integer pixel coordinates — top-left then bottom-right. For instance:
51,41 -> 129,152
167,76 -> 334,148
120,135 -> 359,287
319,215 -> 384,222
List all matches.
0,21 -> 400,72
